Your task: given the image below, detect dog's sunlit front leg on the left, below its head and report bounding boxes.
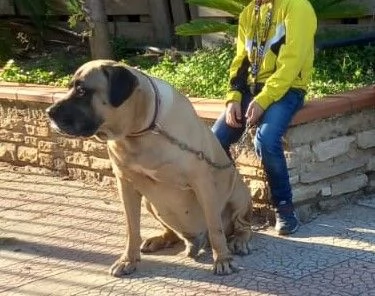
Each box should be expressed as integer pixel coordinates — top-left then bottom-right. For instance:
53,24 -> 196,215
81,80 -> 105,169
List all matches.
109,176 -> 142,277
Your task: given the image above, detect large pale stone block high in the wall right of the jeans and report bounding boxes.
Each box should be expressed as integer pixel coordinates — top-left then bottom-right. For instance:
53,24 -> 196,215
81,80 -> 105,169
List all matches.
312,136 -> 356,161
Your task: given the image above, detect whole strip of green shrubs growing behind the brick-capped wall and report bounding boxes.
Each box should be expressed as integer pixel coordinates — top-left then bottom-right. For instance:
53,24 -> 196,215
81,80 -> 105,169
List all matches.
0,44 -> 375,98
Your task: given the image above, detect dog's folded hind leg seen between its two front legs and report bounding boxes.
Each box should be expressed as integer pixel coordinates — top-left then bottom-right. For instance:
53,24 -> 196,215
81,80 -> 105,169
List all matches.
141,201 -> 181,253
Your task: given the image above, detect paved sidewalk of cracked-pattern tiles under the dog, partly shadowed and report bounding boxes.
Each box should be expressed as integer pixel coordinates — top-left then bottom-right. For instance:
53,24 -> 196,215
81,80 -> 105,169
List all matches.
0,165 -> 375,296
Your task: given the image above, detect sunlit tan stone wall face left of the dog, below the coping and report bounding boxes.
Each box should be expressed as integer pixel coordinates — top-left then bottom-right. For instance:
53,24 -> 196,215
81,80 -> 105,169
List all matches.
0,100 -> 112,183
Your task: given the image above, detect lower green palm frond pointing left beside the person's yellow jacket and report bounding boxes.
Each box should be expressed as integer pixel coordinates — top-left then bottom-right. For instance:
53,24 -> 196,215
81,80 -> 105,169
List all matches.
176,19 -> 237,36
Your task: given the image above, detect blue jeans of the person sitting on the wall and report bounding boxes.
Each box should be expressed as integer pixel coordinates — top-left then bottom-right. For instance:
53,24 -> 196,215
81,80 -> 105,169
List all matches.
212,89 -> 305,207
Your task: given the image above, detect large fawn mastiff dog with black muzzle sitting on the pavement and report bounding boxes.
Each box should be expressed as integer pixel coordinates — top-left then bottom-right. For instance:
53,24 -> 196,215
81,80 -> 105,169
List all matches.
47,60 -> 252,276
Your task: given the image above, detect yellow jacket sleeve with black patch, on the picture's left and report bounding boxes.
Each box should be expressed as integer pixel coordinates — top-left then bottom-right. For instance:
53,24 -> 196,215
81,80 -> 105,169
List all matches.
226,9 -> 249,103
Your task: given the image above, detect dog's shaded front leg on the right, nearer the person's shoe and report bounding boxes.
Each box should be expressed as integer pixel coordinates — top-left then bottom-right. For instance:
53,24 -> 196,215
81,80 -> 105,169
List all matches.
193,169 -> 238,275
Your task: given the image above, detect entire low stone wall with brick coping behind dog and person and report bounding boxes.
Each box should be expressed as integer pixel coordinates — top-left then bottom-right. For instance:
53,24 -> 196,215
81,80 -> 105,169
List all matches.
0,84 -> 375,219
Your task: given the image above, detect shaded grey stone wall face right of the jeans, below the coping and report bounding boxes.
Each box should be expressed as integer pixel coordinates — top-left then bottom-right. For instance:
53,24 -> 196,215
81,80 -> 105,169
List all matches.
286,109 -> 375,210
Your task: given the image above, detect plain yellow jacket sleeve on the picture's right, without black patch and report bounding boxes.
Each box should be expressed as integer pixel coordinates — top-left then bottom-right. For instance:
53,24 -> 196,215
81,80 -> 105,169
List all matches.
255,1 -> 317,110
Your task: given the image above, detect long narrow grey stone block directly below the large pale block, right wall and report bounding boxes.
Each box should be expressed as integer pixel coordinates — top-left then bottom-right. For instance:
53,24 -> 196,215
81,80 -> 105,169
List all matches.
300,158 -> 367,184
